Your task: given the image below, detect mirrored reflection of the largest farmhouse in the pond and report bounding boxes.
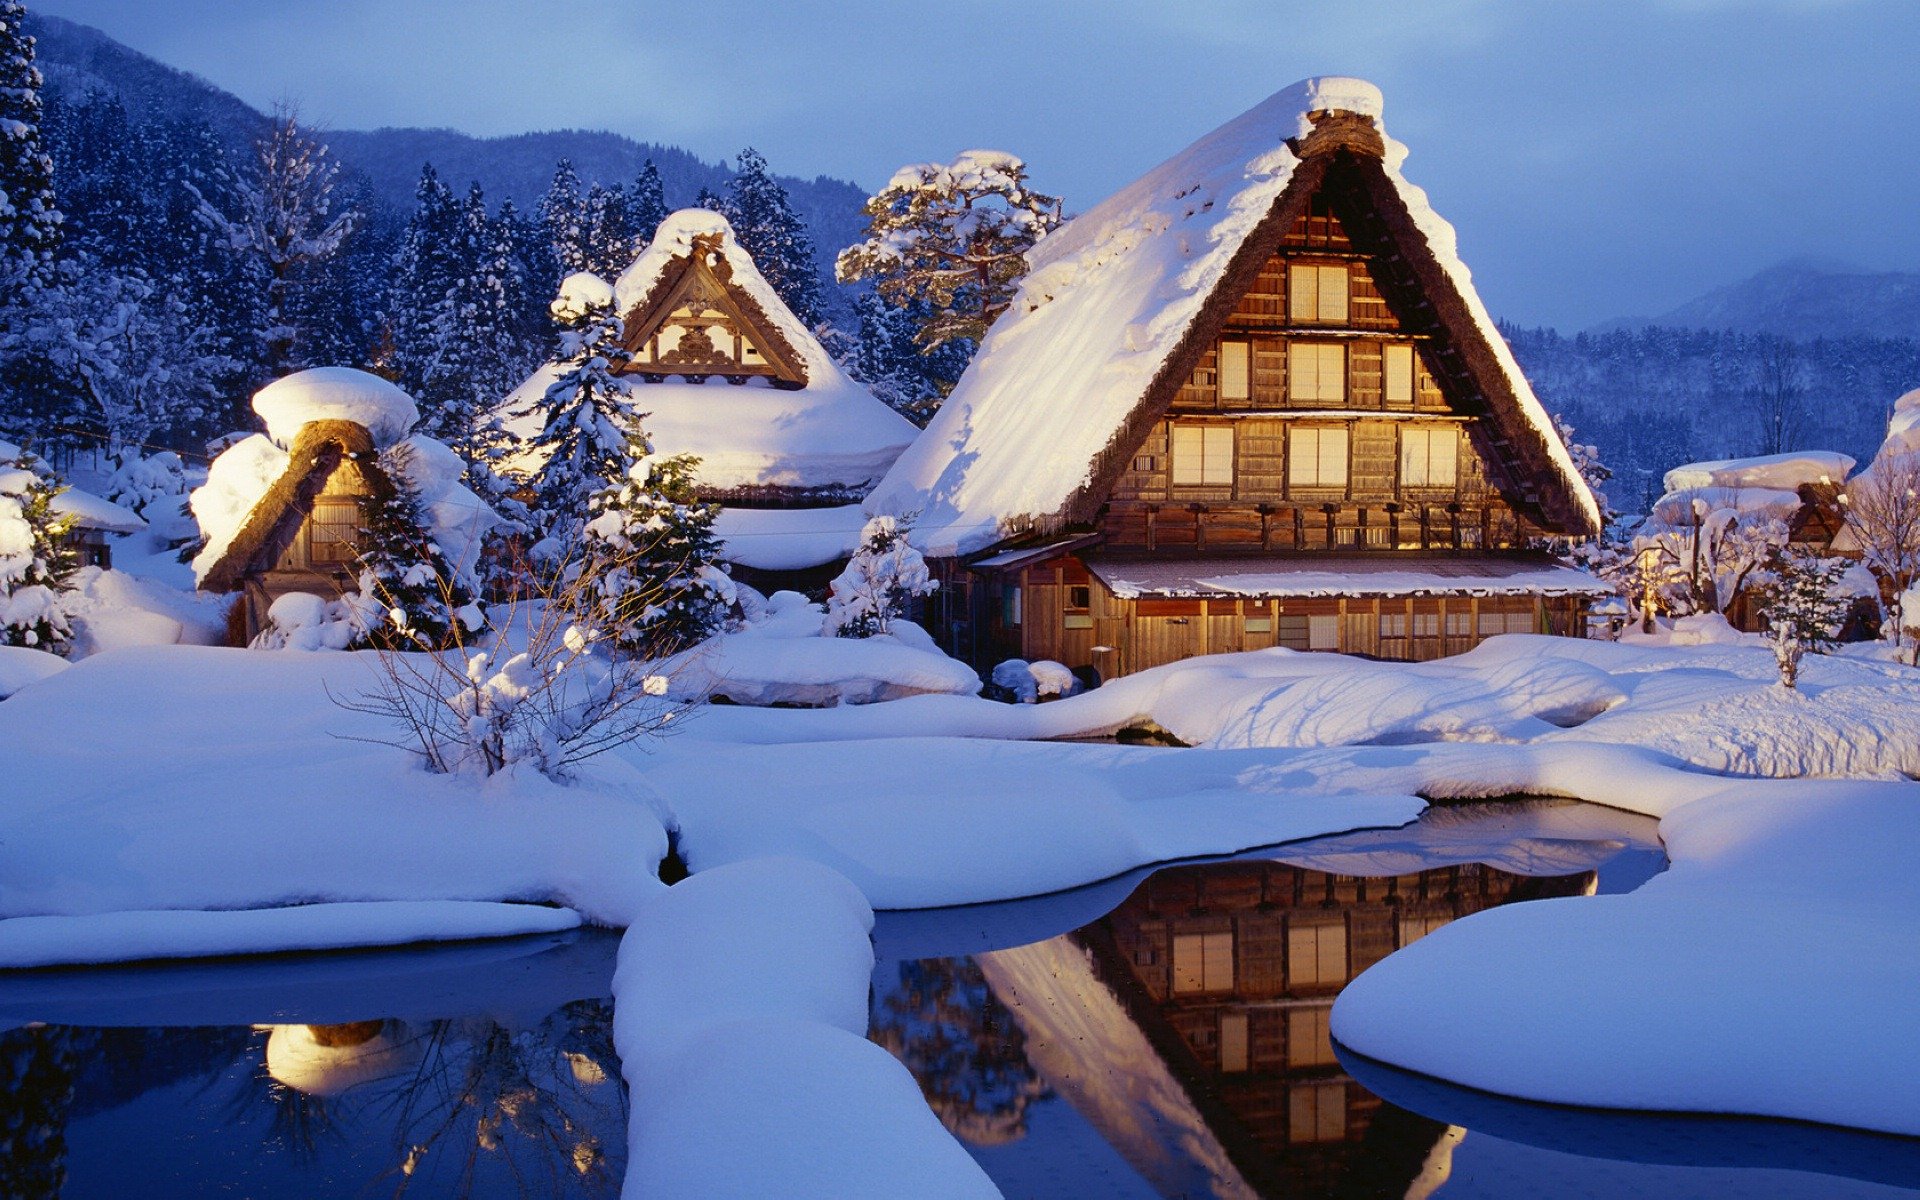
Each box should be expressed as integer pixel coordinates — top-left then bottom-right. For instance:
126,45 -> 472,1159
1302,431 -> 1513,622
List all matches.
981,862 -> 1592,1196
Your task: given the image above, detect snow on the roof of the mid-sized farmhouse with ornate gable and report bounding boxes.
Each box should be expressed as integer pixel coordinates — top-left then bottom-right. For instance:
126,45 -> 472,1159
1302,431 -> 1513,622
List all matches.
501,209 -> 920,492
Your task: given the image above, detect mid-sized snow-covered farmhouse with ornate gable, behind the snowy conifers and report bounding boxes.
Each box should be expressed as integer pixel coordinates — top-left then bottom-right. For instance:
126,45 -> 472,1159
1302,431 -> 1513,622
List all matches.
501,209 -> 918,586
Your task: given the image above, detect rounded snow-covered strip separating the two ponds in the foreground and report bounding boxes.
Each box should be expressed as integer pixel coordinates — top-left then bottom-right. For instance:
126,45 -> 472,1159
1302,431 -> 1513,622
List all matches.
614,858 -> 998,1200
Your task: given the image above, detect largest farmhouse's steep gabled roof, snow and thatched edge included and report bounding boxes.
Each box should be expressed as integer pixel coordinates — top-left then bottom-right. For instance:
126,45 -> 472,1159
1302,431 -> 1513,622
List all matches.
868,79 -> 1601,553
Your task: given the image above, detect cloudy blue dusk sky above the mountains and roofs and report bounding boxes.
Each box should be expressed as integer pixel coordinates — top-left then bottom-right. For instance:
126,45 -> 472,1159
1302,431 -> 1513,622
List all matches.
31,0 -> 1920,328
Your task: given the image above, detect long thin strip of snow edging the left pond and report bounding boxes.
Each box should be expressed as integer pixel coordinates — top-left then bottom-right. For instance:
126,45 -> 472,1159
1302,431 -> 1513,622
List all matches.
0,900 -> 580,968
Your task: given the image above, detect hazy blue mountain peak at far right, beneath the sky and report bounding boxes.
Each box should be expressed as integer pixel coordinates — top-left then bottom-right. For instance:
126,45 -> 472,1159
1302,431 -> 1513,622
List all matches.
1588,259 -> 1920,340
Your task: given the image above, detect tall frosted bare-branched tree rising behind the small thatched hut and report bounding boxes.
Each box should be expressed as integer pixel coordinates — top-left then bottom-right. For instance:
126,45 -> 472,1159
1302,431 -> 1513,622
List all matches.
198,109 -> 361,378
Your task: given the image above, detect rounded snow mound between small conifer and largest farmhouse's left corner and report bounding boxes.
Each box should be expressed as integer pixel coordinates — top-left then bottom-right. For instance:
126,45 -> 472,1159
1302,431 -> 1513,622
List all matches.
660,591 -> 979,707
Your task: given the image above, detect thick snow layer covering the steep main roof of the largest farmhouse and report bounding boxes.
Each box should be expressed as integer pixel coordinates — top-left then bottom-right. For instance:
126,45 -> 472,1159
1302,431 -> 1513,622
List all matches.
868,77 -> 1601,555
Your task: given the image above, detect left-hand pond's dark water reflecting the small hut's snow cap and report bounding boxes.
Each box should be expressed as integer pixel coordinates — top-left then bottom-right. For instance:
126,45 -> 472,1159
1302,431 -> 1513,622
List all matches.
0,933 -> 628,1200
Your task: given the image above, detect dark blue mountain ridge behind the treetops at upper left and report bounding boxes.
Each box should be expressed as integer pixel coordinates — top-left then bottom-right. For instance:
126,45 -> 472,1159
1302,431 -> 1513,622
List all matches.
27,13 -> 866,278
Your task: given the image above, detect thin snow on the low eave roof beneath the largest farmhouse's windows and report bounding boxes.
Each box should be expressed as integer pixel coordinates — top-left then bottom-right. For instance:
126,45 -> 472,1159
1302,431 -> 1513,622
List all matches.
1081,555 -> 1613,599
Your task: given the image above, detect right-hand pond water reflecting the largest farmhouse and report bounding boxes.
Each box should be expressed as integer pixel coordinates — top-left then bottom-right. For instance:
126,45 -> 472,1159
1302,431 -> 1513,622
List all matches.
874,804 -> 1914,1198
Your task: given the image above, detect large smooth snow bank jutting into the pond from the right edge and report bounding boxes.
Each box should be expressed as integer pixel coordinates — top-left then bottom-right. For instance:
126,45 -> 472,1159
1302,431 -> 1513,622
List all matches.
1332,780 -> 1920,1135
